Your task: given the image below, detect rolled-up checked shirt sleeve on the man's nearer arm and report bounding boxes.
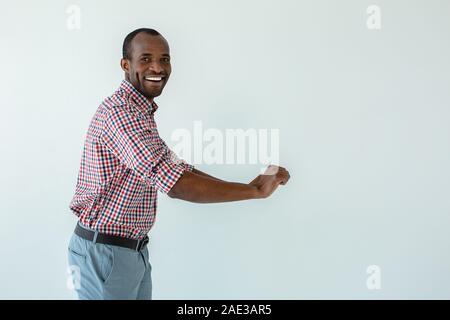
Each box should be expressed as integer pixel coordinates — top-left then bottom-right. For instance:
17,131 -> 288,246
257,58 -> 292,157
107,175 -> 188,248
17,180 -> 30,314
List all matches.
102,108 -> 193,193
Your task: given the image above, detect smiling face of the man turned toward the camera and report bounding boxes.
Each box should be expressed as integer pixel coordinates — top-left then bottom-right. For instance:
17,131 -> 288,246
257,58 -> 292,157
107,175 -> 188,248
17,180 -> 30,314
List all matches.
120,32 -> 172,100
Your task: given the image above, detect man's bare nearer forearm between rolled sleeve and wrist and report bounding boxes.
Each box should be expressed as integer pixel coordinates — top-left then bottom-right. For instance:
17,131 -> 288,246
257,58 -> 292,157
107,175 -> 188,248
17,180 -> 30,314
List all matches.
169,171 -> 257,203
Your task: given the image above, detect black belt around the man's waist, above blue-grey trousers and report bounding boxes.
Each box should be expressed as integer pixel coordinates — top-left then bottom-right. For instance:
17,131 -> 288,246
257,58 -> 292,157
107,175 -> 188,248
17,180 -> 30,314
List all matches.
75,223 -> 149,251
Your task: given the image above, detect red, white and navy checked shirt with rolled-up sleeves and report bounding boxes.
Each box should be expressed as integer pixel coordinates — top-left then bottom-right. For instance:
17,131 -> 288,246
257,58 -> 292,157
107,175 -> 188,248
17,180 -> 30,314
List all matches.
70,80 -> 193,239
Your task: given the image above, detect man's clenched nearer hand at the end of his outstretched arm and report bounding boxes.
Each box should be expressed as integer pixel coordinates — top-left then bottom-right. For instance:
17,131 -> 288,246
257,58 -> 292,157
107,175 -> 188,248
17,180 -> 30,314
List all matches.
249,165 -> 290,199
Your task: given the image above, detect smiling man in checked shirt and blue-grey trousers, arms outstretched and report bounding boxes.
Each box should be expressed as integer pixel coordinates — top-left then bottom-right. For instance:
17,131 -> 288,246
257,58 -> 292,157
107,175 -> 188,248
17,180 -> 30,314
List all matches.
69,28 -> 289,299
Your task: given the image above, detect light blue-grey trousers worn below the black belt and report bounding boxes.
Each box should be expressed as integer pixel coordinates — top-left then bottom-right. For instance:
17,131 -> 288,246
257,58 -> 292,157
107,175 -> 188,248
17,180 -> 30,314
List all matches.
68,225 -> 152,300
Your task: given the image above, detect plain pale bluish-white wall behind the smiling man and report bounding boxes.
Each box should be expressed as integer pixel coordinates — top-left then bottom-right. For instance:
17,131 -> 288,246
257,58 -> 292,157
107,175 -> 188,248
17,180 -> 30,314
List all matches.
0,0 -> 450,299
